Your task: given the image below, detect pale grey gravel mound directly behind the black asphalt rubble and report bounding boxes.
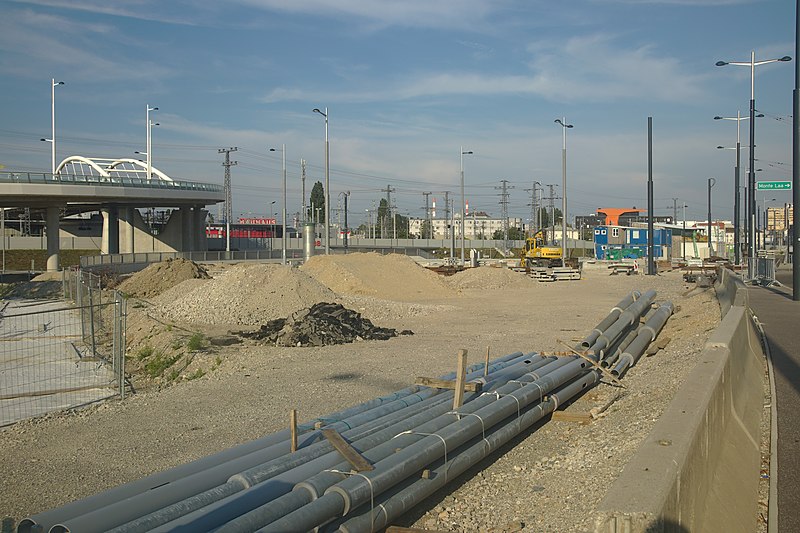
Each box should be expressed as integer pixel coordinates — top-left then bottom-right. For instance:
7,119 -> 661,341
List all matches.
157,264 -> 336,326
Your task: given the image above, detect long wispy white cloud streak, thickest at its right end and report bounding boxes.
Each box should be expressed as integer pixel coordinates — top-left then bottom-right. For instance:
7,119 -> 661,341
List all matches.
262,34 -> 710,103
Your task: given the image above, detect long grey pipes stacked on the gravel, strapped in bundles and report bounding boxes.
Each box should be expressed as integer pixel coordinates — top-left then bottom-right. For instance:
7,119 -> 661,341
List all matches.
18,291 -> 672,533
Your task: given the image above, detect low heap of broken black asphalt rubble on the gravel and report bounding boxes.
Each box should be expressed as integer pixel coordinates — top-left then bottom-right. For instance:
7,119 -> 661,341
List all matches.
238,302 -> 414,346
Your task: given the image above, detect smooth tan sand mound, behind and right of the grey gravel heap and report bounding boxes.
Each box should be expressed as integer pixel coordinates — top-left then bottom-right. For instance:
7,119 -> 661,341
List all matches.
300,252 -> 455,302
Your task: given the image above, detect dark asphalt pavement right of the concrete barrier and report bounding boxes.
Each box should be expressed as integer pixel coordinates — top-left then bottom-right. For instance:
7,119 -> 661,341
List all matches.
748,268 -> 800,531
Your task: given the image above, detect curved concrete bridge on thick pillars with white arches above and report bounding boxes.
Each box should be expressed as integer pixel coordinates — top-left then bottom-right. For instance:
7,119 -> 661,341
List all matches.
0,156 -> 225,271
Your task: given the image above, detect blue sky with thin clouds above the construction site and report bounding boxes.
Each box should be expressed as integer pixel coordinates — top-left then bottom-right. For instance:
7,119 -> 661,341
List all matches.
0,0 -> 795,226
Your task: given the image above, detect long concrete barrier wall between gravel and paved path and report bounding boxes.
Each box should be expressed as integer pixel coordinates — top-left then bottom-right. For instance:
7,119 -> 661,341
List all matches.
595,271 -> 764,533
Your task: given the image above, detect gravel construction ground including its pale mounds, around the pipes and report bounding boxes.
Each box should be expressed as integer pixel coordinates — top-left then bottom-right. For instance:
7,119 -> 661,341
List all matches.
0,254 -> 720,532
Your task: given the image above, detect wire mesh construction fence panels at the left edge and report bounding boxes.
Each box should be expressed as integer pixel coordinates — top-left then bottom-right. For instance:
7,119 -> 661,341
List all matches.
0,269 -> 126,426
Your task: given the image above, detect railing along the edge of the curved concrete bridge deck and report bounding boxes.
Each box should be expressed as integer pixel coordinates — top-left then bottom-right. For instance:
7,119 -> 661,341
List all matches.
0,172 -> 223,192
